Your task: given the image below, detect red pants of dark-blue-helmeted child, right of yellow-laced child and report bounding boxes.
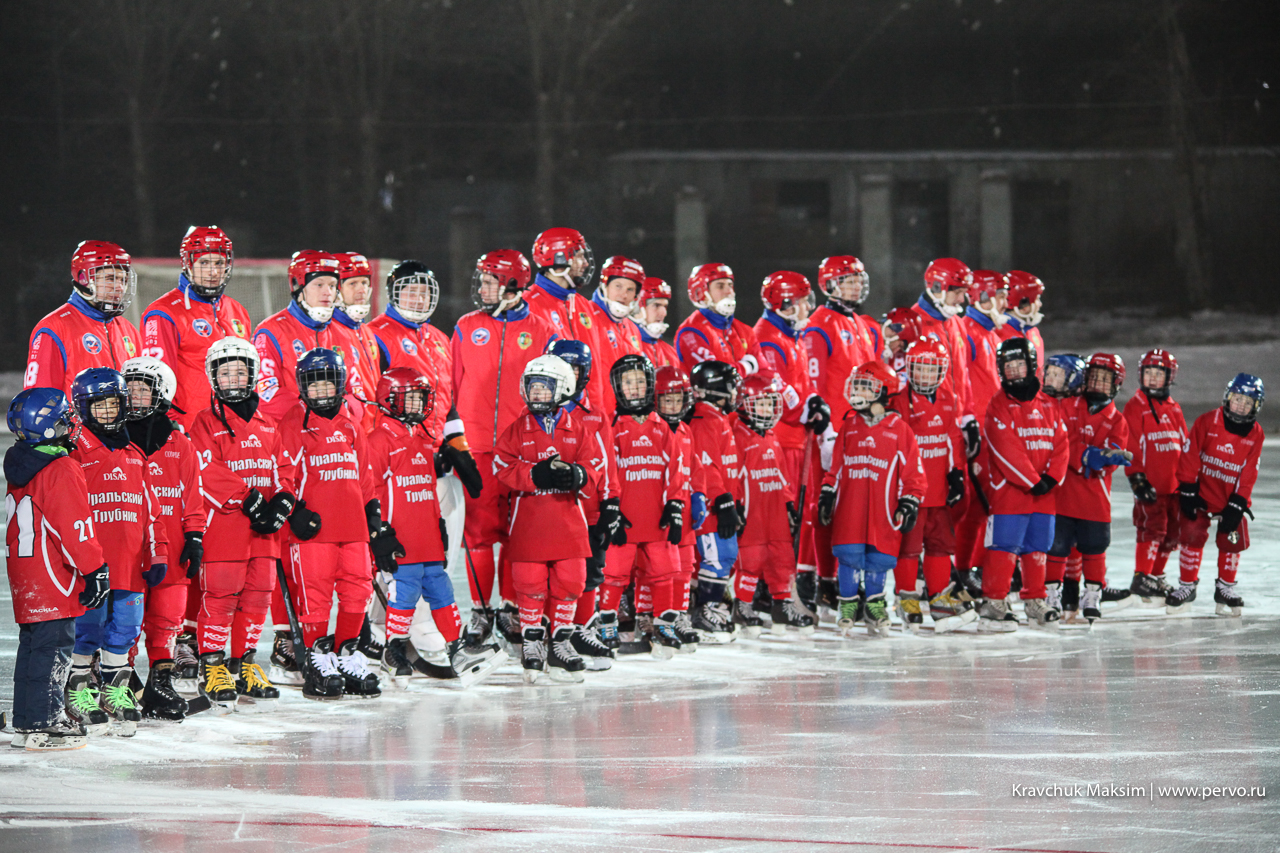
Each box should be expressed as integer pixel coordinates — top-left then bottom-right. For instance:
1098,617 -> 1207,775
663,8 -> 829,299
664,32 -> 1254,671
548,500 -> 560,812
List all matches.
285,542 -> 372,648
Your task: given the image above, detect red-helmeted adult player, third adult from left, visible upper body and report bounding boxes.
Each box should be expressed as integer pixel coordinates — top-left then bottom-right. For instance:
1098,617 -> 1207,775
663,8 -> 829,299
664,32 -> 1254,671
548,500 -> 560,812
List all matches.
253,248 -> 347,420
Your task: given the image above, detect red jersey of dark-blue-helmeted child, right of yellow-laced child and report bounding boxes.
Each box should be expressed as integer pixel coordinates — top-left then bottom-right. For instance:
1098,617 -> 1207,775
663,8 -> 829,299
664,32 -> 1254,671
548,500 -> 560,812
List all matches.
280,401 -> 374,543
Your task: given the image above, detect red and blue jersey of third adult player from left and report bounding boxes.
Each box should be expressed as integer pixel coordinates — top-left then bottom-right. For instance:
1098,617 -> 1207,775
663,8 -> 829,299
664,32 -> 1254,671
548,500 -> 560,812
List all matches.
253,300 -> 351,420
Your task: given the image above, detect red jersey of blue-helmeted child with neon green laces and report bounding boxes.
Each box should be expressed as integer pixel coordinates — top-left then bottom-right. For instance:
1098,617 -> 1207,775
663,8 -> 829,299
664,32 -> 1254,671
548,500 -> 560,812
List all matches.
70,429 -> 165,592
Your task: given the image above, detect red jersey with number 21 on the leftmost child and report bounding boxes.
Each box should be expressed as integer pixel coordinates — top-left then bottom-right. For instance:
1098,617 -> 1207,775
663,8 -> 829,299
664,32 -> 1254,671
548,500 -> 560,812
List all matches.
4,444 -> 106,625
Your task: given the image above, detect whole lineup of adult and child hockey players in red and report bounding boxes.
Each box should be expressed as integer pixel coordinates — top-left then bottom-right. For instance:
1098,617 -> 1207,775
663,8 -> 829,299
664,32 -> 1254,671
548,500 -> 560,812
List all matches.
4,227 -> 1270,752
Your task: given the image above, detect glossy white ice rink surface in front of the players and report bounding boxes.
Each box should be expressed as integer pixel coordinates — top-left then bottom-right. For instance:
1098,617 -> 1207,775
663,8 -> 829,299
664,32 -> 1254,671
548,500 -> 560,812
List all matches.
0,444 -> 1280,853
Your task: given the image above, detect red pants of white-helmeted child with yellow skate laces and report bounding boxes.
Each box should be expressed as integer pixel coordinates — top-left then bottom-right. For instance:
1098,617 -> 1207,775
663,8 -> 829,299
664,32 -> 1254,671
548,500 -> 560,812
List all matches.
197,557 -> 275,657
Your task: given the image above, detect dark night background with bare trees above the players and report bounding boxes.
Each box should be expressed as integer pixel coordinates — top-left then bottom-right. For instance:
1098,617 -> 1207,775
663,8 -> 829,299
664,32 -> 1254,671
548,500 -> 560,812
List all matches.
0,0 -> 1280,370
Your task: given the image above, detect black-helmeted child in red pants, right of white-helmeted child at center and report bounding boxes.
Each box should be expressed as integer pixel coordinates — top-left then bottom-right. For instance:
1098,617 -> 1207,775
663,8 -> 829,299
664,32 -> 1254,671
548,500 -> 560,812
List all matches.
599,353 -> 689,660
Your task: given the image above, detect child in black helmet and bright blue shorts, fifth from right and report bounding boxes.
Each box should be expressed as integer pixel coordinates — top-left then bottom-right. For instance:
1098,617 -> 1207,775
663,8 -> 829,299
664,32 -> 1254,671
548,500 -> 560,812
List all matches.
978,338 -> 1070,633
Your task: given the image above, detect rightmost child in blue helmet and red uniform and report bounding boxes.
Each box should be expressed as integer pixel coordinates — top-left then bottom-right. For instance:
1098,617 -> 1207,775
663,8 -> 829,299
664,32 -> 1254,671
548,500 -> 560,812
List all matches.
1165,373 -> 1266,616
